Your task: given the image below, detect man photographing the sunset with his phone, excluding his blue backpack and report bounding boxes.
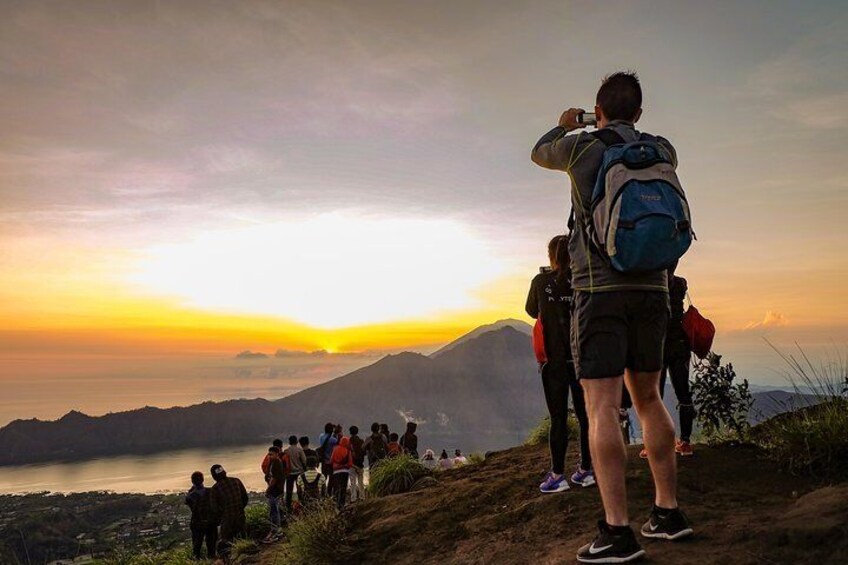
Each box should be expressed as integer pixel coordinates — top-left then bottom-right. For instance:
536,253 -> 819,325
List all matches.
531,72 -> 693,563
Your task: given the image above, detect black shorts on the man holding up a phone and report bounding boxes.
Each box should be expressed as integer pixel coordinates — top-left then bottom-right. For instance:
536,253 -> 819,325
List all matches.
571,290 -> 670,379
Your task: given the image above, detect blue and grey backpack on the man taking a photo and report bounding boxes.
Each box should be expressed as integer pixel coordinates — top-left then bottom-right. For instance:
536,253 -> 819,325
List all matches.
585,129 -> 695,273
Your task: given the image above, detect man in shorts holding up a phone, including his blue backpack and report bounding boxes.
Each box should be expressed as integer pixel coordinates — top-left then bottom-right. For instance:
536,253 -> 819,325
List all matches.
531,73 -> 693,563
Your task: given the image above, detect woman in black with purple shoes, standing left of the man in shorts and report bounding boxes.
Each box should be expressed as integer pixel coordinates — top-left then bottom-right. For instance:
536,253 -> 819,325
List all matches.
524,235 -> 595,494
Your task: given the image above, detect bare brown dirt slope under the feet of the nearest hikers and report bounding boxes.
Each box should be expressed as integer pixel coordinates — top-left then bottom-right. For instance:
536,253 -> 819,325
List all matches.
253,440 -> 848,565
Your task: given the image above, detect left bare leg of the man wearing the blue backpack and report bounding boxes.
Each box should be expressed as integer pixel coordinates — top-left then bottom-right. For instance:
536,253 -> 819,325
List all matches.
580,376 -> 628,526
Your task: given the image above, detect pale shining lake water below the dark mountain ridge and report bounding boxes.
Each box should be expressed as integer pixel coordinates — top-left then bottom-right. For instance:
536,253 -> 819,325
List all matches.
0,444 -> 268,494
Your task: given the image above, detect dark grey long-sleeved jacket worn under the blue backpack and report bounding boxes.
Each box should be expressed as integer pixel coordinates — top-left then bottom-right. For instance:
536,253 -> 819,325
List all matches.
530,121 -> 677,292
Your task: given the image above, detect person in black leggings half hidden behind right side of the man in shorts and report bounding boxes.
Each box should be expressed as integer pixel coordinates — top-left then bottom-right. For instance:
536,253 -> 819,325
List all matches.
660,265 -> 695,457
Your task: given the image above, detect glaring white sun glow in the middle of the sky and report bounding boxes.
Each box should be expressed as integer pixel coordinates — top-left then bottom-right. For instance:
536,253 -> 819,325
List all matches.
129,213 -> 505,329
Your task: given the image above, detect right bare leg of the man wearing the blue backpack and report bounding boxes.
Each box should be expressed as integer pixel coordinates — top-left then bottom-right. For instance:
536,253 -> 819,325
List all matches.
628,370 -> 677,509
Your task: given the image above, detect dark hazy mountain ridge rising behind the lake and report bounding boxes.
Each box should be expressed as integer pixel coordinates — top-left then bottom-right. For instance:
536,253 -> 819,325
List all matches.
0,322 -> 810,465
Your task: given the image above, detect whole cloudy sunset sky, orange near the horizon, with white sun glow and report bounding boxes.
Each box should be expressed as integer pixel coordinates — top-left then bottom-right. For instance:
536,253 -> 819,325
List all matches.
0,0 -> 848,424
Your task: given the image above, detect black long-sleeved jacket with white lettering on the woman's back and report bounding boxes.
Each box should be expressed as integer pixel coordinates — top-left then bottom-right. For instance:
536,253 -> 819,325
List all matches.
525,271 -> 574,362
